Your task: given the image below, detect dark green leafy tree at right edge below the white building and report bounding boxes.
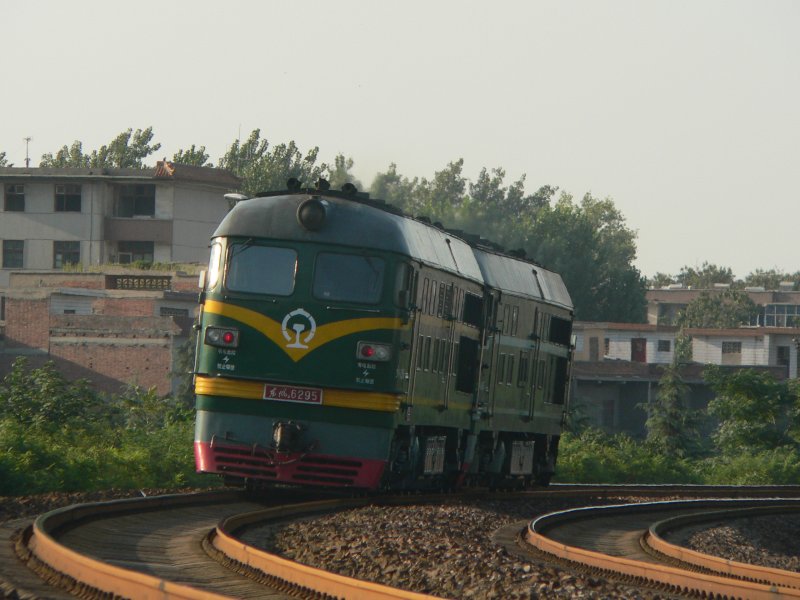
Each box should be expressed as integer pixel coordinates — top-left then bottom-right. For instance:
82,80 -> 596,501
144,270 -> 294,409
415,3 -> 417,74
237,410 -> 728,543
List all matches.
704,365 -> 800,455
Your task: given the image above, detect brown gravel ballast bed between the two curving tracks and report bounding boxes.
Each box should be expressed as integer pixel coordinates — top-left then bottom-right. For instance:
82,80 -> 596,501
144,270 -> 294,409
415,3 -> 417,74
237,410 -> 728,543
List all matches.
250,498 -> 673,599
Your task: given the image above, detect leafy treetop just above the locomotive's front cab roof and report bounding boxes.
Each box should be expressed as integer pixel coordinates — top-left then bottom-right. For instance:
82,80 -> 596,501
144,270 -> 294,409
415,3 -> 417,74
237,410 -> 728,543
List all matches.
218,129 -> 328,195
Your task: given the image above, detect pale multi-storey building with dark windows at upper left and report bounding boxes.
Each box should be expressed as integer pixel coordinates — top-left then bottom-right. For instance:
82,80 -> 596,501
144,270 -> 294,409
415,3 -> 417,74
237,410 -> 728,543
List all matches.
0,161 -> 240,321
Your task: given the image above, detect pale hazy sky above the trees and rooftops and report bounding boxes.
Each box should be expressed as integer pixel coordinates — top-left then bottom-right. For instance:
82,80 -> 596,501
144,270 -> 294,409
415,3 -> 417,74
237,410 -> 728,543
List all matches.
0,0 -> 800,277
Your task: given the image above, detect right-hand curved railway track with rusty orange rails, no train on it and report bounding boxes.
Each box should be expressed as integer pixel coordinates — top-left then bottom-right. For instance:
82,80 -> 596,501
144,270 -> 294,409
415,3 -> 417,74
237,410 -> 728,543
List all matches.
524,498 -> 800,599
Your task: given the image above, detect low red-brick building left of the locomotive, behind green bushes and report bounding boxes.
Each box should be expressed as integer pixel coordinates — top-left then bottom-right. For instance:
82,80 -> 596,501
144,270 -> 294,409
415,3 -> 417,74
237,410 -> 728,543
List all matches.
0,268 -> 197,394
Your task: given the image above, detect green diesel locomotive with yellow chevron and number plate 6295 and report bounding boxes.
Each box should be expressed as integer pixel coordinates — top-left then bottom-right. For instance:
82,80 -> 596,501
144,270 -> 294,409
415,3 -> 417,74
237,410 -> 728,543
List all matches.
194,180 -> 573,490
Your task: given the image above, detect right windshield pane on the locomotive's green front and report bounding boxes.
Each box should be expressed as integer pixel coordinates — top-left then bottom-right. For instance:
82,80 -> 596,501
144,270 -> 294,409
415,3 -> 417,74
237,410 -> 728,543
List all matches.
313,252 -> 385,304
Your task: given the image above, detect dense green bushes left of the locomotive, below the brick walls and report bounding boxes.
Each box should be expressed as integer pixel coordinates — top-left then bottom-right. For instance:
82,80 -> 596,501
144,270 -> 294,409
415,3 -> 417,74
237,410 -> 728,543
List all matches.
0,358 -> 209,496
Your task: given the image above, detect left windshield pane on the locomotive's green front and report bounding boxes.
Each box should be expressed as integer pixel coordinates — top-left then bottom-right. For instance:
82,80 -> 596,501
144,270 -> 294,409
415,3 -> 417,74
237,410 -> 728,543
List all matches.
225,242 -> 297,296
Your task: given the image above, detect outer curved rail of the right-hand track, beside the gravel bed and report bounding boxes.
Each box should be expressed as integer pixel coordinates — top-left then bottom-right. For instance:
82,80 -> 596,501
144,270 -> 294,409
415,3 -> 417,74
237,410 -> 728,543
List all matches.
525,500 -> 800,600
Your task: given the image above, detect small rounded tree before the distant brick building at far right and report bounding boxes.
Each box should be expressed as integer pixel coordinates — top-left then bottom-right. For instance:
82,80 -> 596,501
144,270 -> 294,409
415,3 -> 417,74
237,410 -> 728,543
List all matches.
677,289 -> 759,329
